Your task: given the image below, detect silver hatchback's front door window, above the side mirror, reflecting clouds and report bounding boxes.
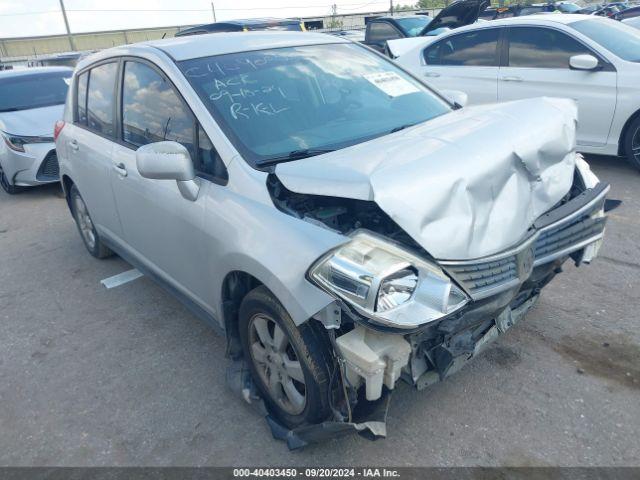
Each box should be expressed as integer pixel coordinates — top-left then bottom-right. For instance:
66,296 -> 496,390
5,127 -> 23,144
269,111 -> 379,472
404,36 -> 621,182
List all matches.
122,62 -> 196,158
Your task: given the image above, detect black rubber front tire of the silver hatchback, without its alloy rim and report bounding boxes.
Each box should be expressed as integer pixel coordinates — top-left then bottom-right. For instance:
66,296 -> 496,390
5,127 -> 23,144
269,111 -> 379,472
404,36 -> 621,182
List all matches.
238,286 -> 332,428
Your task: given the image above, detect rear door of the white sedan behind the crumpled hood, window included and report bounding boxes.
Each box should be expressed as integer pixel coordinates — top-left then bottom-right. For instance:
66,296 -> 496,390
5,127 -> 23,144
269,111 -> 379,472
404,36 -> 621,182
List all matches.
421,28 -> 502,104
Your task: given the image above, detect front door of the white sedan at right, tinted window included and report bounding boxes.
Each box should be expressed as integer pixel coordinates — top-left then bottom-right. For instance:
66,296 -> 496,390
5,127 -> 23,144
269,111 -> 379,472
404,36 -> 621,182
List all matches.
498,26 -> 616,146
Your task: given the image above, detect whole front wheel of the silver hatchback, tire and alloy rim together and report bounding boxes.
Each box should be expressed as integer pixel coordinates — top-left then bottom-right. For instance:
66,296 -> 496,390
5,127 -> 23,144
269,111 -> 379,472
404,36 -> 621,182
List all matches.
239,286 -> 331,428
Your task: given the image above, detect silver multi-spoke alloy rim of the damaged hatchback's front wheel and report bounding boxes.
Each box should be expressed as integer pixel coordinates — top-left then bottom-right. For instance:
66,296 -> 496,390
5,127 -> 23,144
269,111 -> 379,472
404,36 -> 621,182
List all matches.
249,313 -> 307,415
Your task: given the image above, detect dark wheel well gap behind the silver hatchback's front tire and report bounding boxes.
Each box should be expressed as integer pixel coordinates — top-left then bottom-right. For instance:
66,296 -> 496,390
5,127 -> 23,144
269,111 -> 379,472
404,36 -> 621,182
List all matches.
222,271 -> 263,359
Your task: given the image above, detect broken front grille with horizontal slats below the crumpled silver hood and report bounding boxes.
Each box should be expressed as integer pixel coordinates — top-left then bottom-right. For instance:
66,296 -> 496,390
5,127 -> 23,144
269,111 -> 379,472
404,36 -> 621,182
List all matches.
441,188 -> 606,300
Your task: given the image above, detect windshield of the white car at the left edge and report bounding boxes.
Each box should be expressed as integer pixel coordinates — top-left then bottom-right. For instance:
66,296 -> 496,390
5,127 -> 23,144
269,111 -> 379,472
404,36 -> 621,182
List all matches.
0,70 -> 71,112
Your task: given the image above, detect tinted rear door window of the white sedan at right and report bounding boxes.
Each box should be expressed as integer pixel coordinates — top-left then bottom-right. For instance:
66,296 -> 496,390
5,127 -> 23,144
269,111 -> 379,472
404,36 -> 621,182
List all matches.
424,28 -> 499,67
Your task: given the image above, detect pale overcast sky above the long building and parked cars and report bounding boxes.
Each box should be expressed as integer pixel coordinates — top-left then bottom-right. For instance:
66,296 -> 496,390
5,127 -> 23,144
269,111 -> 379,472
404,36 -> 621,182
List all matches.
0,0 -> 392,38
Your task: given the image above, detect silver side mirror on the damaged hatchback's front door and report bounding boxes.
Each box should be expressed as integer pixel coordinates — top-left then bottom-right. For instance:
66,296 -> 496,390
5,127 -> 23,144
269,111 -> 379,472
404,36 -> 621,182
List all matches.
136,142 -> 200,201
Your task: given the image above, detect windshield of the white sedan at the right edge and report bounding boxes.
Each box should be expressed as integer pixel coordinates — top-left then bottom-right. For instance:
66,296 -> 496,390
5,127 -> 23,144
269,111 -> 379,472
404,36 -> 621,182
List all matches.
570,20 -> 640,62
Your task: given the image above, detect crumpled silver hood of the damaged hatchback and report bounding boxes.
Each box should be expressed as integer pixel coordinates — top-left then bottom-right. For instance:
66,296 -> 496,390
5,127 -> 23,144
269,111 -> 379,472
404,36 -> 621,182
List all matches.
275,98 -> 577,260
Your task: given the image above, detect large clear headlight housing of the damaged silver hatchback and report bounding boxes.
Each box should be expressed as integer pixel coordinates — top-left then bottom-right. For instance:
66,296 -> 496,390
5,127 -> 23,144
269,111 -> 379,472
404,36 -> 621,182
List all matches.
309,231 -> 469,329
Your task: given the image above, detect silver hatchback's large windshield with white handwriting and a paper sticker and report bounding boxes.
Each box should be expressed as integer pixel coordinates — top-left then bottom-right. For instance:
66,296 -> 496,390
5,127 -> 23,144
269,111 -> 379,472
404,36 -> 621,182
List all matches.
179,44 -> 451,165
